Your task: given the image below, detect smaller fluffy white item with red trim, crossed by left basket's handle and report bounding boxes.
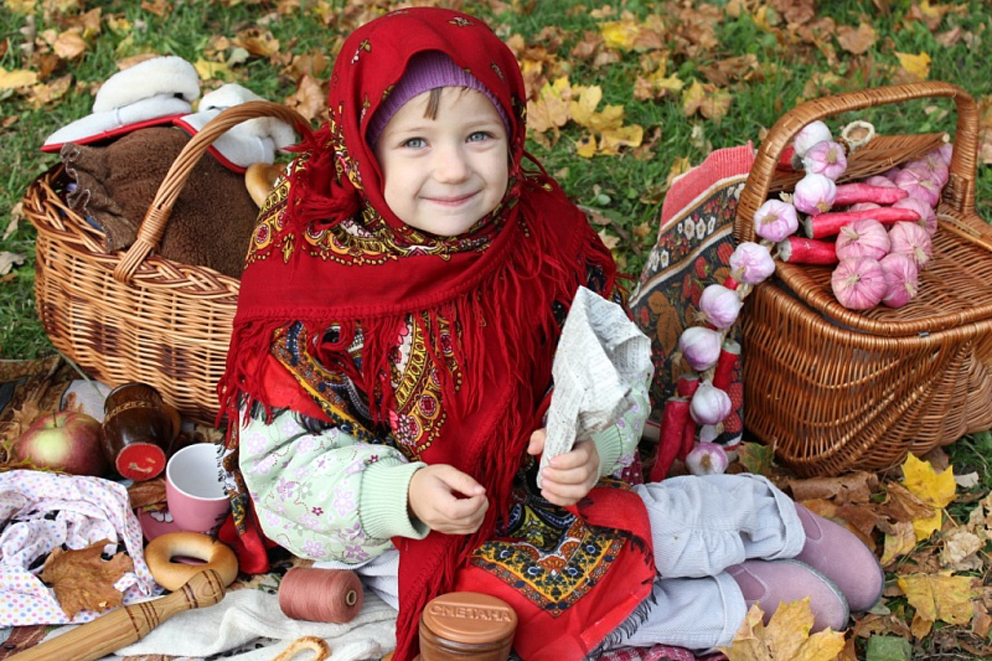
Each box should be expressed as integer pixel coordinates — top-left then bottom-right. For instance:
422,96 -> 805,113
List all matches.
175,83 -> 296,168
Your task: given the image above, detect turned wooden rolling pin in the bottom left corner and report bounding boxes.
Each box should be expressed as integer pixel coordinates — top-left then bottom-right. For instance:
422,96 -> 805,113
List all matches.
8,569 -> 224,661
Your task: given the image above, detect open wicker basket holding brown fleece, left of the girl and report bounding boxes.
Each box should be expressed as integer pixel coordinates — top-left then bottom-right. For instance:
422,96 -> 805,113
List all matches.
24,101 -> 310,423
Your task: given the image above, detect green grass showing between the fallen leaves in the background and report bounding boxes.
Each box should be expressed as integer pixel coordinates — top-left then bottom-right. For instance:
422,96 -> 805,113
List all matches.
0,0 -> 992,358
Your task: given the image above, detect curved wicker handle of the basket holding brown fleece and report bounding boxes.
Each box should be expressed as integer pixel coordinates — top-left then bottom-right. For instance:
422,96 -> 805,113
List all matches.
114,101 -> 311,283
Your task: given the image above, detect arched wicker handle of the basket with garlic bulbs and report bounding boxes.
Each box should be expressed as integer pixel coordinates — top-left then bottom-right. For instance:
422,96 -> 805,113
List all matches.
734,82 -> 978,241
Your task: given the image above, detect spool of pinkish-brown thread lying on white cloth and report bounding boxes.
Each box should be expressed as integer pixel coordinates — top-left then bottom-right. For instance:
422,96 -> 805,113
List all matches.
279,567 -> 364,622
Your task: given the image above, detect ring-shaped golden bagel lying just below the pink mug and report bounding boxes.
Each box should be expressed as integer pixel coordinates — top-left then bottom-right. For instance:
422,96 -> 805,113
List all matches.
145,532 -> 238,592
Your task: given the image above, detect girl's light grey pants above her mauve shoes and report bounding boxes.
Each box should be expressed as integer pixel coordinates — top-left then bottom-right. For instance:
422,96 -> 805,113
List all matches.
603,474 -> 806,649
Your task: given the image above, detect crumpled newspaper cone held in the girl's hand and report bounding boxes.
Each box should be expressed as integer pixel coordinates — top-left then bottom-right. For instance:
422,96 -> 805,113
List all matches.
537,287 -> 654,485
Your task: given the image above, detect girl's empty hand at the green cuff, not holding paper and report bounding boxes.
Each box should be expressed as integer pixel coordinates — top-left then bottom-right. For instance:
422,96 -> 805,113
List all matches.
407,464 -> 489,535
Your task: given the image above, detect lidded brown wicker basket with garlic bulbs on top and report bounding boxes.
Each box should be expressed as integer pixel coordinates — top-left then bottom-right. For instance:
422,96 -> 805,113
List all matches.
735,83 -> 992,475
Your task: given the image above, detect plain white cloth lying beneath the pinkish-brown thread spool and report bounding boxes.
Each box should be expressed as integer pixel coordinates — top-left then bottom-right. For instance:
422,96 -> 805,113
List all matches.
89,589 -> 396,661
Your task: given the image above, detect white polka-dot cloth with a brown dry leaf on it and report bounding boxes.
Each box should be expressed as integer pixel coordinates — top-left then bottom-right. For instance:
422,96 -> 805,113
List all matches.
0,470 -> 157,626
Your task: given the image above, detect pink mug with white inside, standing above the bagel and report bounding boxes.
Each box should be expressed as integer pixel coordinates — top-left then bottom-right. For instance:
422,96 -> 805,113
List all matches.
165,443 -> 231,532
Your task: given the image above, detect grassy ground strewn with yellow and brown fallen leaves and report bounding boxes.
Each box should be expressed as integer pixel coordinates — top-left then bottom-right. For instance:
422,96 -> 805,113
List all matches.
0,0 -> 992,661
